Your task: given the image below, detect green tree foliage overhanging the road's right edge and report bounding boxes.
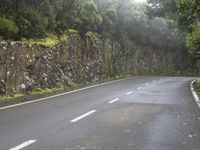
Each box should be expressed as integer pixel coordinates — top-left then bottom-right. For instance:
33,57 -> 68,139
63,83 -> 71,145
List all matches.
148,0 -> 200,63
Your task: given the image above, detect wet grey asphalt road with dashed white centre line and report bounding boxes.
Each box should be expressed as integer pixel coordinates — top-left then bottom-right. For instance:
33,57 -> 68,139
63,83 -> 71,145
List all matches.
0,77 -> 200,150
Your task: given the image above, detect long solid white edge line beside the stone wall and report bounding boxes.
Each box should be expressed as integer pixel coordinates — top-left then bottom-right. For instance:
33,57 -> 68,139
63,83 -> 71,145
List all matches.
0,76 -> 143,110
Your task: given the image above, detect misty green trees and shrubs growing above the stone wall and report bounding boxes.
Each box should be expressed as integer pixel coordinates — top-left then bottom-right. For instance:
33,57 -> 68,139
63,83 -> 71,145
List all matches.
0,0 -> 183,50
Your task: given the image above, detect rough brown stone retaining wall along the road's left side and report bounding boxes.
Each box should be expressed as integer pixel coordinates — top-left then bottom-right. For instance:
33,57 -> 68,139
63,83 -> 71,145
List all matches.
0,32 -> 194,95
